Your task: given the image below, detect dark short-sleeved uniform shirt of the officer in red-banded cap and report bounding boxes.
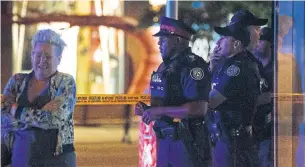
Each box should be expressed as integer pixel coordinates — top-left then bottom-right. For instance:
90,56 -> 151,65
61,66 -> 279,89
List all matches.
150,48 -> 210,106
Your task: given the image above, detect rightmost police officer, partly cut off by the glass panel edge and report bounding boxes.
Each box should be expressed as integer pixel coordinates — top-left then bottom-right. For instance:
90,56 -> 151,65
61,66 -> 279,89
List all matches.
254,27 -> 274,167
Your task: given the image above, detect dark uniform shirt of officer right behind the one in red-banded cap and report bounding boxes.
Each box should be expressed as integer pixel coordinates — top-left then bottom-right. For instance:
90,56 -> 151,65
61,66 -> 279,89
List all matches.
212,51 -> 260,124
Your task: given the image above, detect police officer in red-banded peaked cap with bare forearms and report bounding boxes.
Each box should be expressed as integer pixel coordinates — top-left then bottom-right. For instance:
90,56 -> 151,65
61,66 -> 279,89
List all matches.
135,17 -> 211,167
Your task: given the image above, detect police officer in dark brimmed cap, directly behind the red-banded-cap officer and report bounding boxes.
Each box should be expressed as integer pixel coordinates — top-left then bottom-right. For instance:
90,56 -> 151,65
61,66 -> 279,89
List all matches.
207,23 -> 260,167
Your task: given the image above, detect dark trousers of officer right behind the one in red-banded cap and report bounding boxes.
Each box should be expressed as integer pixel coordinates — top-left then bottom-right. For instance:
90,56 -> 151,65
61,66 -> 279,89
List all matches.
212,141 -> 258,167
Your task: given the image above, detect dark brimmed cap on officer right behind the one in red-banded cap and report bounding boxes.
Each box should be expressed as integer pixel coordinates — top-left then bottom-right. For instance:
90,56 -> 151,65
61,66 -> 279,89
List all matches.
214,22 -> 250,47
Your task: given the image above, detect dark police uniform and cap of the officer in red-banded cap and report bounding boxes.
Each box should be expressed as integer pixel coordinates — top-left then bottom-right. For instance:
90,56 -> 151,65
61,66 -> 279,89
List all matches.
150,17 -> 210,167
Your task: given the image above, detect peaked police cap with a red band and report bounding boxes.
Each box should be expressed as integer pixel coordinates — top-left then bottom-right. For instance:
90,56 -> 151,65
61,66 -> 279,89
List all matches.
153,16 -> 196,40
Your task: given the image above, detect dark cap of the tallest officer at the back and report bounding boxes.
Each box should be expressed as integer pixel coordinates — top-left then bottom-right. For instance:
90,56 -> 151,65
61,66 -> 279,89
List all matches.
231,9 -> 268,26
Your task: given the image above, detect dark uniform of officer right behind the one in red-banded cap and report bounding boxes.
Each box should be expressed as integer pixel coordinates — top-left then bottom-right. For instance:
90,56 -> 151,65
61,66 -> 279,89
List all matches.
209,52 -> 260,167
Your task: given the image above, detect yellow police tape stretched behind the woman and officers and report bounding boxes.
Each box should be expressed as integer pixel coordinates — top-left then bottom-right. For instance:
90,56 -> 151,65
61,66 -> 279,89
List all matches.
1,93 -> 305,105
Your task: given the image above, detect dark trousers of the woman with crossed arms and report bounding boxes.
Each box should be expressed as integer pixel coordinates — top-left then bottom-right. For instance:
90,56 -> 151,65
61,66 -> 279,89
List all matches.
12,129 -> 76,167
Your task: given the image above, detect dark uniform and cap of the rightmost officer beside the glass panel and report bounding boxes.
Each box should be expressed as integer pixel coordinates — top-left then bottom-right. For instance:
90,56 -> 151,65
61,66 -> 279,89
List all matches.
254,27 -> 274,167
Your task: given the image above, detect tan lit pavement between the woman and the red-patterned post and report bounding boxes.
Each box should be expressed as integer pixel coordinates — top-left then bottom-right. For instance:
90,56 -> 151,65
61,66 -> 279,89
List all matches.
75,125 -> 139,167
